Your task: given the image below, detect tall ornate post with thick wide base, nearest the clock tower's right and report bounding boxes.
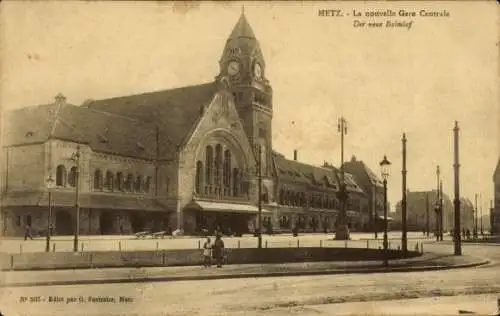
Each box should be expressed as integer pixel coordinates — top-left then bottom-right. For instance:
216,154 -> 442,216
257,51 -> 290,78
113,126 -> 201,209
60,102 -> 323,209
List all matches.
335,117 -> 349,240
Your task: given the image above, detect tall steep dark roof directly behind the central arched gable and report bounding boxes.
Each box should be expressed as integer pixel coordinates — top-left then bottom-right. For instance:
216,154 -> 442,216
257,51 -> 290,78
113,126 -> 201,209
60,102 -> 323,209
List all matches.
86,82 -> 218,159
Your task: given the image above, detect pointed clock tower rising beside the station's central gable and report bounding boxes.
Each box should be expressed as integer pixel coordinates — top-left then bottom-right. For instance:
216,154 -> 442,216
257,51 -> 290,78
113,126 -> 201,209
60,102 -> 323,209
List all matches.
216,12 -> 273,177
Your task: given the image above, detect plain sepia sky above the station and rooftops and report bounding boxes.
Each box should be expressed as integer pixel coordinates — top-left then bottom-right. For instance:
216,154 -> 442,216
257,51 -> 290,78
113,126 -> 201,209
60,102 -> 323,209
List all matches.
0,1 -> 500,214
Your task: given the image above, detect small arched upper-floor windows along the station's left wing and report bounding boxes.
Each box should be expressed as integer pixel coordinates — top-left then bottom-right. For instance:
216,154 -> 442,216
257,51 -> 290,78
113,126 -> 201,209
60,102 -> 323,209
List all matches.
52,165 -> 152,193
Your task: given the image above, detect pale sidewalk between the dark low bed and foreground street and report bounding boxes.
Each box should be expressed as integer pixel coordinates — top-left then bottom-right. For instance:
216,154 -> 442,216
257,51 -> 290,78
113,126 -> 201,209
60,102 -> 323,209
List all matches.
0,253 -> 488,287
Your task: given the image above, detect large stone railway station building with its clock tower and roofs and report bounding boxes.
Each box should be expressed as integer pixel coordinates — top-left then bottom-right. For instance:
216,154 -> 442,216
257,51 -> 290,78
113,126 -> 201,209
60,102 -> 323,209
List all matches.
1,14 -> 370,235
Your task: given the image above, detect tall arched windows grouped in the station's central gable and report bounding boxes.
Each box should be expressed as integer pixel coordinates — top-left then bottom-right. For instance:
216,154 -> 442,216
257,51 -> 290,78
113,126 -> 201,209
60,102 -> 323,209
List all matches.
195,144 -> 245,197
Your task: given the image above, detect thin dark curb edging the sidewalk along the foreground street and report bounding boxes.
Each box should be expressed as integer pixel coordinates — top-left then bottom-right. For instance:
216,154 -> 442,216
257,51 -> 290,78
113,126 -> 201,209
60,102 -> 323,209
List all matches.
0,261 -> 490,288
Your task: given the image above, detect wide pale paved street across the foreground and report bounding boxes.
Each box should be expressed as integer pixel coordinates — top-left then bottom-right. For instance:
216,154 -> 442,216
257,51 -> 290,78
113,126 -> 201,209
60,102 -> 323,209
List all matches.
0,242 -> 500,316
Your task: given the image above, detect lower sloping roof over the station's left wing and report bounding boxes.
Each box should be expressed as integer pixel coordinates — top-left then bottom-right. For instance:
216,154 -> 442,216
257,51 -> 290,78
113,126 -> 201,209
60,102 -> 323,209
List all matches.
2,102 -> 156,159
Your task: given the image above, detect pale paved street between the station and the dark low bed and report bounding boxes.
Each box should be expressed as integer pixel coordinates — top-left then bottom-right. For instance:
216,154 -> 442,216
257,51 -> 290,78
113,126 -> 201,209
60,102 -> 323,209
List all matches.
0,232 -> 432,253
